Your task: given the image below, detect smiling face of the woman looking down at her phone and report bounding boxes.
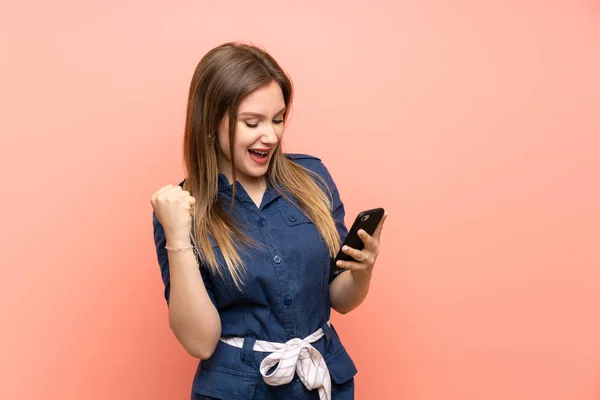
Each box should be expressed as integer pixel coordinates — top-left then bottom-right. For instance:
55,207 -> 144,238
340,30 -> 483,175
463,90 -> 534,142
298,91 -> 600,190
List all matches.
217,81 -> 285,188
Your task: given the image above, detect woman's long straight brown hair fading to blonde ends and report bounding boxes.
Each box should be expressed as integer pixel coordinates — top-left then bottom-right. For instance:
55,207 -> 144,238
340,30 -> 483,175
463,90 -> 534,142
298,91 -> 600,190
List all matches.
183,43 -> 340,289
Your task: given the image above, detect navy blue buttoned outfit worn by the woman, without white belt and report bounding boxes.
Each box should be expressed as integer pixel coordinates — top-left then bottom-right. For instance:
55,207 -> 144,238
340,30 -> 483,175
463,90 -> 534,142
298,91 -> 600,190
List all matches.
153,154 -> 356,399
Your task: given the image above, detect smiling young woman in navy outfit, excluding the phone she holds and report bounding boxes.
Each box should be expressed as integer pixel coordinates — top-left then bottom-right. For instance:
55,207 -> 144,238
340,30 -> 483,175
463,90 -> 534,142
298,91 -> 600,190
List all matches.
151,43 -> 385,400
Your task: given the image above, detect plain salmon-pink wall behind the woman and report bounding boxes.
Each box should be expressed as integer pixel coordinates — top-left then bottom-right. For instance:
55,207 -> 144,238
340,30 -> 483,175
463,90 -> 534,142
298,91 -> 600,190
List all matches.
0,0 -> 600,400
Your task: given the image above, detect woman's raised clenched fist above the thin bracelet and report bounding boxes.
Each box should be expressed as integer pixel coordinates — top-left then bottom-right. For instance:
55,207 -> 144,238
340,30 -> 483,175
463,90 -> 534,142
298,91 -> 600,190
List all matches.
150,185 -> 196,246
